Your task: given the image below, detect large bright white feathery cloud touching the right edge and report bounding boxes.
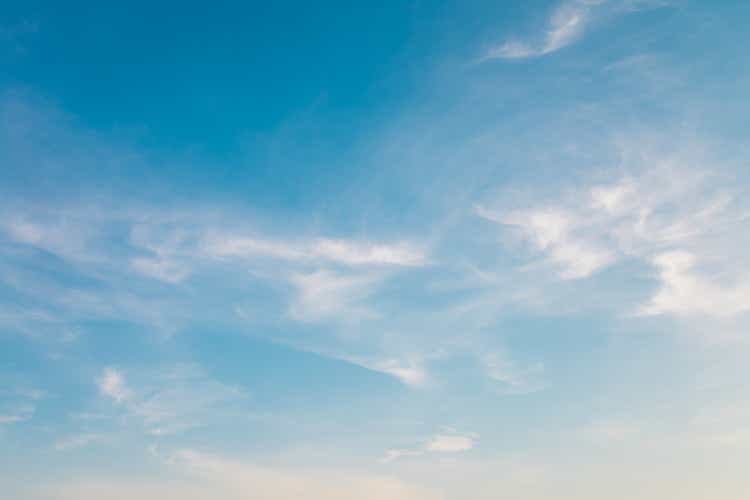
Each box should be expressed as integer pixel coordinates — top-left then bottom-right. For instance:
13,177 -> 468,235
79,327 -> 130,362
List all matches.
476,162 -> 750,326
